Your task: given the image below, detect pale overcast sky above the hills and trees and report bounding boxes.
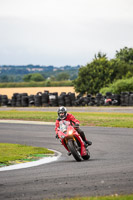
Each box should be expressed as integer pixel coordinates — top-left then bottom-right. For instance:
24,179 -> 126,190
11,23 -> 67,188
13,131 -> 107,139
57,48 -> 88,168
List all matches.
0,0 -> 133,66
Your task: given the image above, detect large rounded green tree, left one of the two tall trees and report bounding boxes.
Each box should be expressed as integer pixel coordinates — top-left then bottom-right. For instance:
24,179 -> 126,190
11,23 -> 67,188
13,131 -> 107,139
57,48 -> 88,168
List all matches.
73,53 -> 114,94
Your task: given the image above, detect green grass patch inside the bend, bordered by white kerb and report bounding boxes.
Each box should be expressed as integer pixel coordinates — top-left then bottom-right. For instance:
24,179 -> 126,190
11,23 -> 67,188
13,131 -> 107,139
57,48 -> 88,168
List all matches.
0,143 -> 54,167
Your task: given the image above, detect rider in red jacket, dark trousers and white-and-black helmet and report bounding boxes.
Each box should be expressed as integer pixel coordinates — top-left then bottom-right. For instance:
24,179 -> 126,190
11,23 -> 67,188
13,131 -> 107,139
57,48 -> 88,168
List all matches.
55,106 -> 92,146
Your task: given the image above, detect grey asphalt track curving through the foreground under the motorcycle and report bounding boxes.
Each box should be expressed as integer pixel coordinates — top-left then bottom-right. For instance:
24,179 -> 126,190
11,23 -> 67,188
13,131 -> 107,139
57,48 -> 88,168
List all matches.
0,123 -> 133,200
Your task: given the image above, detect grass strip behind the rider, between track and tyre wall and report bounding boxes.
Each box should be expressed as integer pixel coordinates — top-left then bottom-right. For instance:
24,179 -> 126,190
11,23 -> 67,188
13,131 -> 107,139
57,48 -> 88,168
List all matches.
0,110 -> 133,128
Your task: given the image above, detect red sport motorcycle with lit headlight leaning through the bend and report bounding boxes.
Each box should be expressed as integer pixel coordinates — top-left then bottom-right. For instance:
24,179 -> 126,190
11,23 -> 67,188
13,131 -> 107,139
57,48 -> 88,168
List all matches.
58,120 -> 90,161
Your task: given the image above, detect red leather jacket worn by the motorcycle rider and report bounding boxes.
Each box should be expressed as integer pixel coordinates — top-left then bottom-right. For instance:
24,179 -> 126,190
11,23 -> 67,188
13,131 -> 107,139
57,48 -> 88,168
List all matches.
55,113 -> 79,134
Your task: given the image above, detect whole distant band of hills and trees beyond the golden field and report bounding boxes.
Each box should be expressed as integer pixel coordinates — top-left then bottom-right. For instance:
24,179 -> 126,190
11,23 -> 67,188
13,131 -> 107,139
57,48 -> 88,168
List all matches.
0,65 -> 80,83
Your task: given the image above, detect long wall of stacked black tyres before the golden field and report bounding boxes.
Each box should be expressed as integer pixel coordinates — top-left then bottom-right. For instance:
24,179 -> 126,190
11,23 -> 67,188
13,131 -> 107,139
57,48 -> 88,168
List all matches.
0,91 -> 133,107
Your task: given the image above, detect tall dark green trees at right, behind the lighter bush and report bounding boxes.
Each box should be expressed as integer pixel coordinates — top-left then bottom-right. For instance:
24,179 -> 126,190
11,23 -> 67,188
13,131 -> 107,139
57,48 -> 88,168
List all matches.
73,47 -> 133,94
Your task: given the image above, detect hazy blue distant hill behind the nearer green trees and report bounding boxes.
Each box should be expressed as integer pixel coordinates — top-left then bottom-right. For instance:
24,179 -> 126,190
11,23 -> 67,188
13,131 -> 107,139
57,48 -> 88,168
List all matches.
0,64 -> 80,82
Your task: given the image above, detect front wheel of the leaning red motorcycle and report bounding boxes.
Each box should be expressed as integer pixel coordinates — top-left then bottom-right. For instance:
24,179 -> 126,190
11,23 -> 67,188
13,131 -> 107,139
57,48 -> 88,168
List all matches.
67,140 -> 82,161
